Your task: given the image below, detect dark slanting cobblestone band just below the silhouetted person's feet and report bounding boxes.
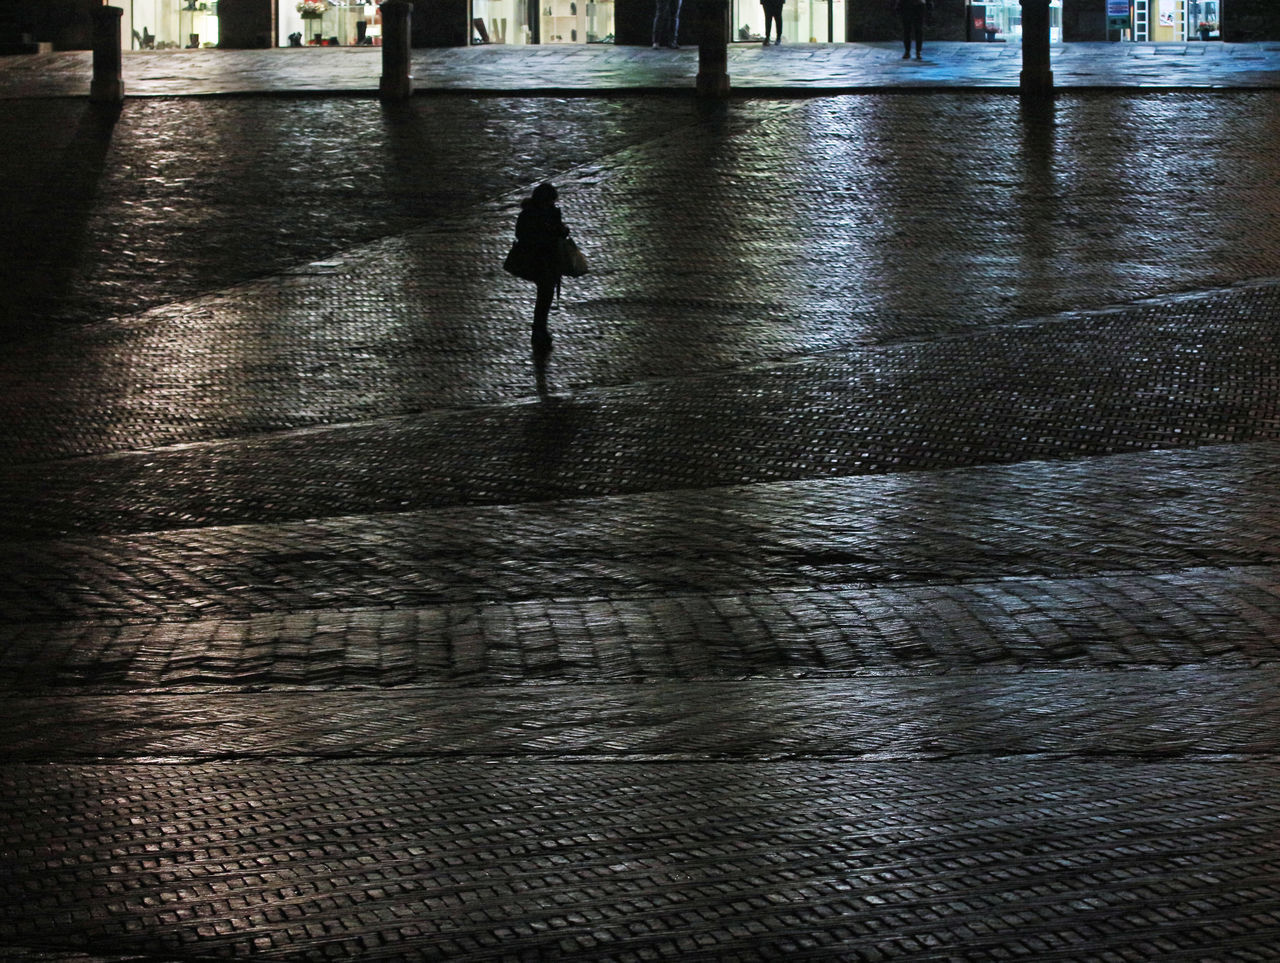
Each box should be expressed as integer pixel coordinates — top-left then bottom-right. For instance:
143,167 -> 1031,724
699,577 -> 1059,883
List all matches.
0,277 -> 1280,538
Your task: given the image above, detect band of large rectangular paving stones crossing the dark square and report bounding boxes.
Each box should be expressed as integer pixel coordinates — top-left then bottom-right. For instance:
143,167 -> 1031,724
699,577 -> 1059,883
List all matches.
0,566 -> 1280,693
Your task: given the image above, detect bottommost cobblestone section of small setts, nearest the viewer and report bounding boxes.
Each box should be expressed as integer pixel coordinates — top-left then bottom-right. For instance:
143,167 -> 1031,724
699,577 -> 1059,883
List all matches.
0,759 -> 1280,960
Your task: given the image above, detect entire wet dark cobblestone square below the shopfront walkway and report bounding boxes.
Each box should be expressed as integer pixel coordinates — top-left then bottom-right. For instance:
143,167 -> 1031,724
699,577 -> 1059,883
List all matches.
0,54 -> 1280,960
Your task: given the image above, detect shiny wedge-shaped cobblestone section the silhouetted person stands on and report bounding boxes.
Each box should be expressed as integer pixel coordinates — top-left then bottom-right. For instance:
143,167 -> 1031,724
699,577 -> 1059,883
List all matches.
9,96 -> 1280,458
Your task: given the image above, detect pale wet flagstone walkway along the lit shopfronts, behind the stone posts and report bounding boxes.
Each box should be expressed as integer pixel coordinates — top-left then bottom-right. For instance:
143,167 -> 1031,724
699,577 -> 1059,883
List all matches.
0,38 -> 1280,99
